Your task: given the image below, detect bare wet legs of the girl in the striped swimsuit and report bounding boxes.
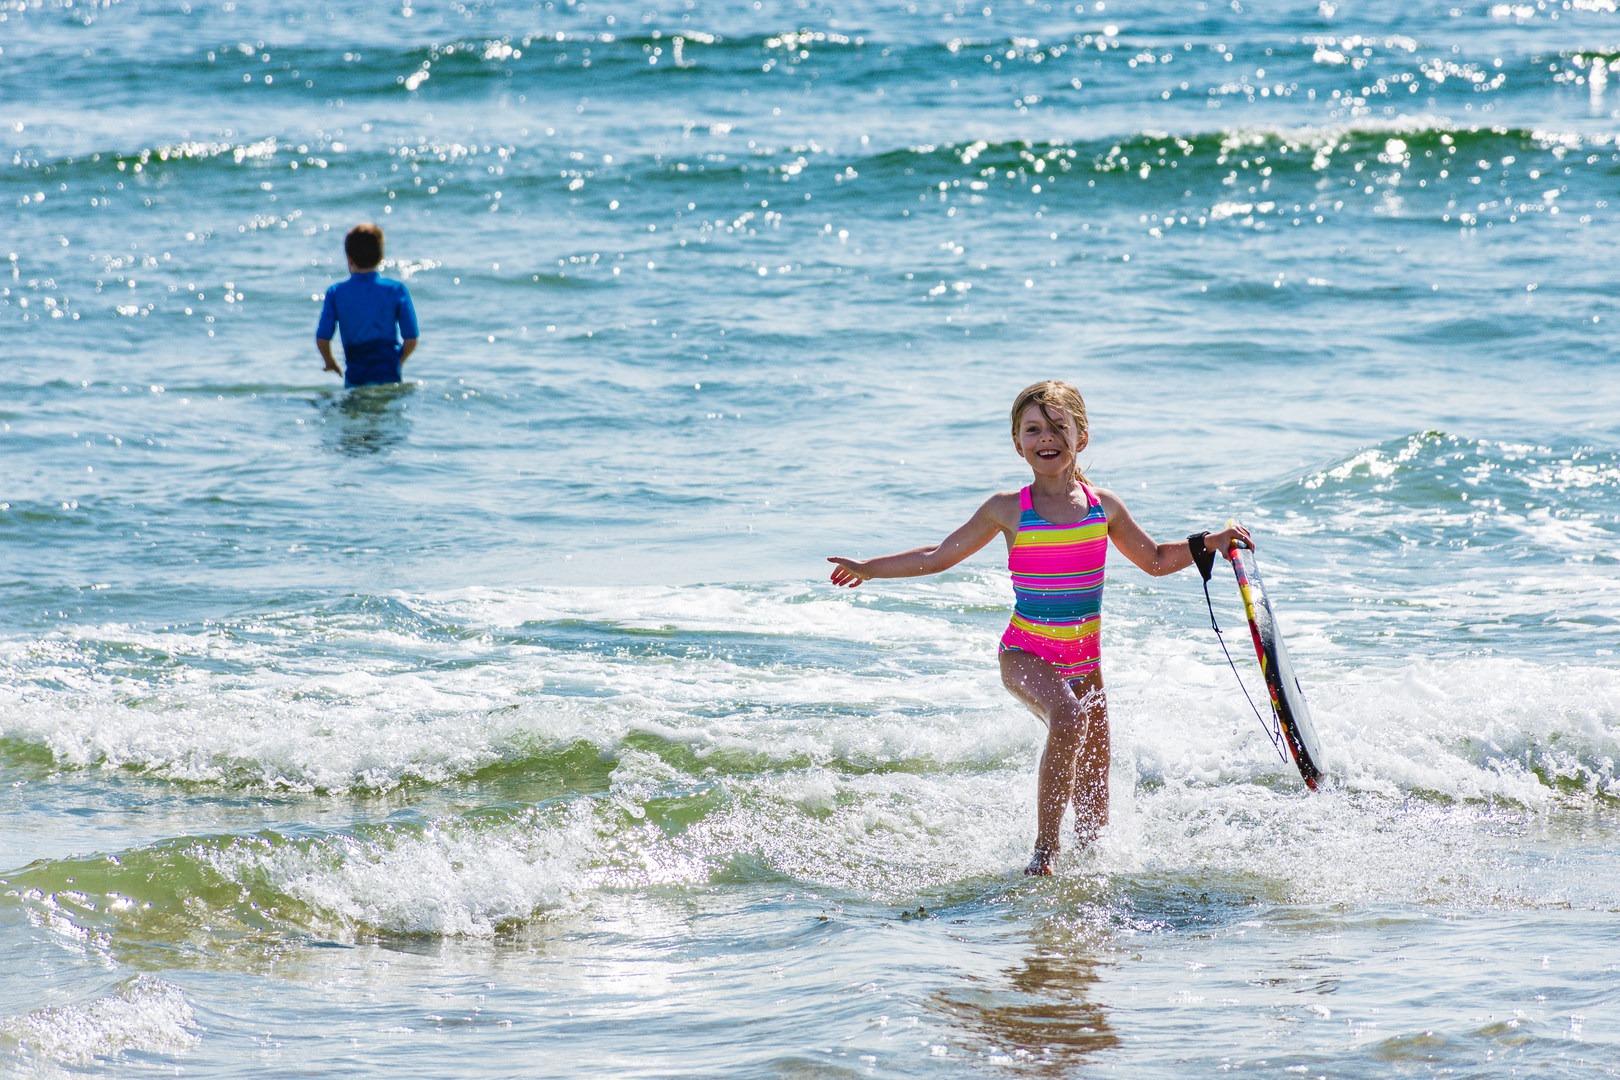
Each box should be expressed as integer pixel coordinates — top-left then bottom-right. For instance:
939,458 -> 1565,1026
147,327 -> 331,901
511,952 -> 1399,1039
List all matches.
1001,649 -> 1108,873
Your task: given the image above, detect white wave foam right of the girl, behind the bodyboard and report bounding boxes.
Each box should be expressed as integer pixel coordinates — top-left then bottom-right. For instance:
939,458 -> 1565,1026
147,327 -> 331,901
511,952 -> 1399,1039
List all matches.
1111,641 -> 1620,806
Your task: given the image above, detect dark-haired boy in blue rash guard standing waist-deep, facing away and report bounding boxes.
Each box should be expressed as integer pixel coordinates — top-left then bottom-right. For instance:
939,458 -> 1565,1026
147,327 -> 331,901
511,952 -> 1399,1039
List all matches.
314,222 -> 416,387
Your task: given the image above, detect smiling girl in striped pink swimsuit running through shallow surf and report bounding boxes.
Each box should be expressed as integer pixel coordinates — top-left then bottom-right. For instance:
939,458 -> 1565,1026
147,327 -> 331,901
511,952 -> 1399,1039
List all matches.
828,381 -> 1252,874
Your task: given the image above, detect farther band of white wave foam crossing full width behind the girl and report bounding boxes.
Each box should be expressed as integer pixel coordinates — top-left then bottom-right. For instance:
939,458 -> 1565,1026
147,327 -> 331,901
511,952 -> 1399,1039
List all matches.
0,585 -> 1620,805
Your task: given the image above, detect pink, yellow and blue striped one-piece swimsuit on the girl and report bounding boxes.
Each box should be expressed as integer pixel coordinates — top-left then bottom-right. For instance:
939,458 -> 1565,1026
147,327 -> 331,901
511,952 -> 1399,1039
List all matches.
1001,484 -> 1108,682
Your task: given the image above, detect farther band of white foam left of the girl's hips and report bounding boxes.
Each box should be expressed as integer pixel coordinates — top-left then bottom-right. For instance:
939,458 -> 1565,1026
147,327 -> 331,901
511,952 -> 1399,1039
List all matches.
0,589 -> 1023,790
